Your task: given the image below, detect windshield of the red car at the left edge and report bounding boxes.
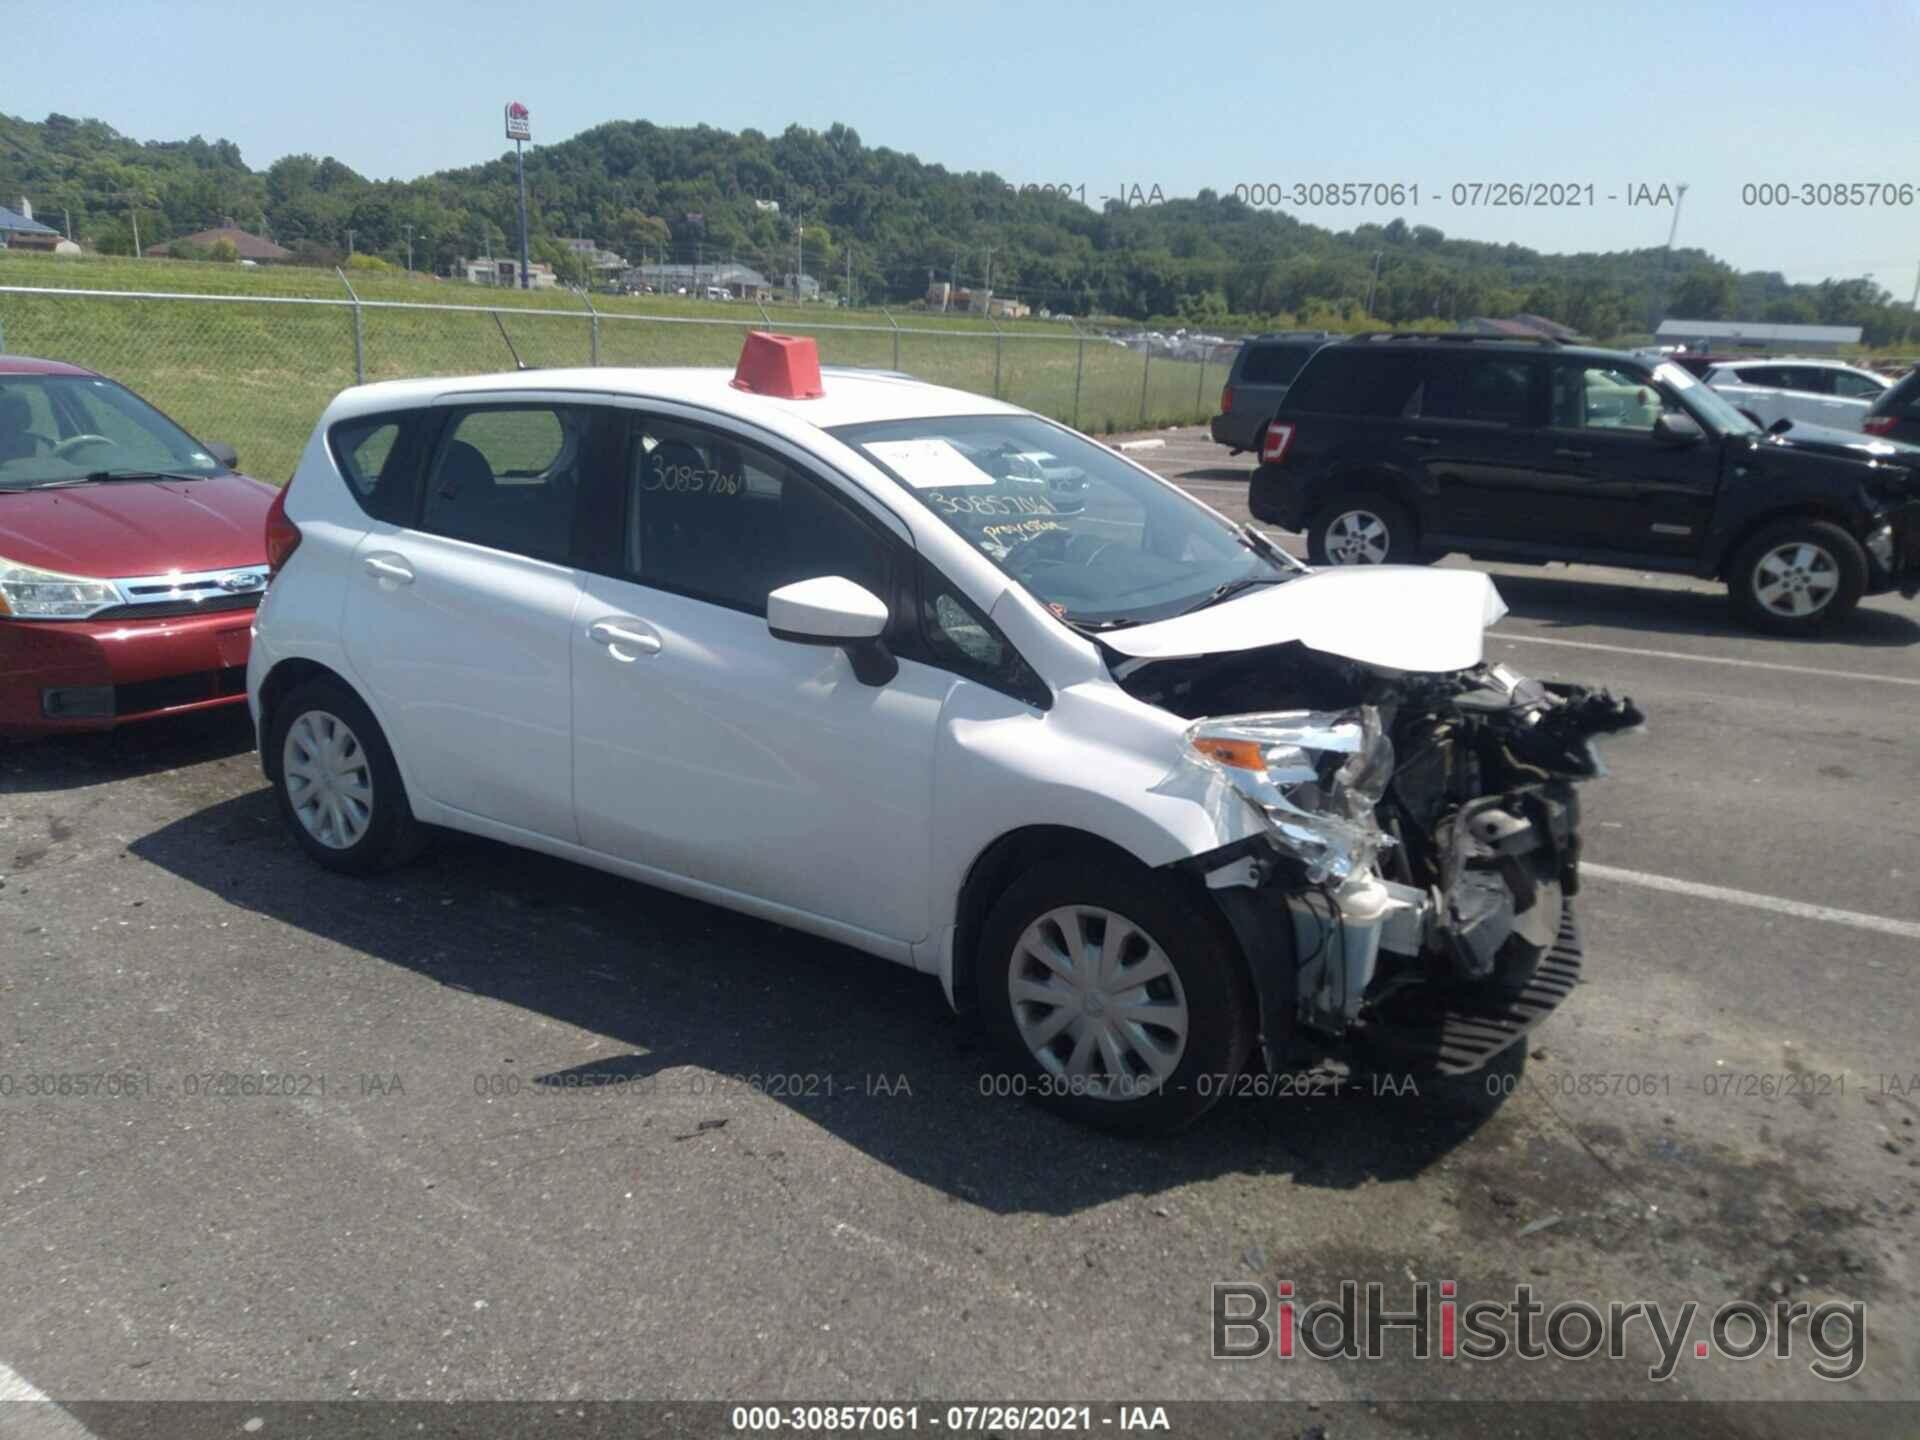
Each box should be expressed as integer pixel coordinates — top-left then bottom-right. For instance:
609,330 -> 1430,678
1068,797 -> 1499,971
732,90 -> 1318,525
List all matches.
0,374 -> 227,490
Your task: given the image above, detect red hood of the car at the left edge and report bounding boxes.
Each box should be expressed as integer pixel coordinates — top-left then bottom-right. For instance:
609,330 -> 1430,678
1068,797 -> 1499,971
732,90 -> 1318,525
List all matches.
0,474 -> 273,580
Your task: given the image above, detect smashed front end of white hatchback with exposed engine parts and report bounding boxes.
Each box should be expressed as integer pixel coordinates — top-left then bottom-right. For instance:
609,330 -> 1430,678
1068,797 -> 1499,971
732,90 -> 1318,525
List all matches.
1117,643 -> 1642,1073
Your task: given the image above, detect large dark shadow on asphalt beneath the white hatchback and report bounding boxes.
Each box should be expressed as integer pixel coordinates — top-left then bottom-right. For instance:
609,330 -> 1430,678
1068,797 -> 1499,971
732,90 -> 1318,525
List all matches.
131,789 -> 1524,1215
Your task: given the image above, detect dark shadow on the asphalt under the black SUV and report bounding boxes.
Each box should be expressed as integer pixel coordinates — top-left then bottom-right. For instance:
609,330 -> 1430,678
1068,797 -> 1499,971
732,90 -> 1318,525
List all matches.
1494,570 -> 1920,659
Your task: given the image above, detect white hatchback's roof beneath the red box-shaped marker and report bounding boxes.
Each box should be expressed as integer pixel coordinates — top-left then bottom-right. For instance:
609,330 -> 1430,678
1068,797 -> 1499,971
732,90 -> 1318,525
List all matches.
334,365 -> 1025,430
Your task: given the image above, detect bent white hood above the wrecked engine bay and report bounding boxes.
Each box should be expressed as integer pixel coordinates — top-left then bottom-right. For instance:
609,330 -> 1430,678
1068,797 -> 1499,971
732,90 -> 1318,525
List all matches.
1100,564 -> 1507,672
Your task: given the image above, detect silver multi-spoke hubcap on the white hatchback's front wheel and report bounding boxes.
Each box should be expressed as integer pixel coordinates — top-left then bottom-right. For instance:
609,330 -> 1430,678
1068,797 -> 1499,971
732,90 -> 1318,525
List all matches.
1006,904 -> 1187,1100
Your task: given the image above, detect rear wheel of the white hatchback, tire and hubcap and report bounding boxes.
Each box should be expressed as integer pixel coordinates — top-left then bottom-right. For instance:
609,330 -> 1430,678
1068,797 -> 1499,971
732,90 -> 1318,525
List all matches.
267,678 -> 426,876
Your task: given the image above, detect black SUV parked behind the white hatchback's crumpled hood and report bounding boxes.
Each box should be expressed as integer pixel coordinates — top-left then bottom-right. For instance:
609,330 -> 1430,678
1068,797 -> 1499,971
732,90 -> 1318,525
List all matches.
1248,334 -> 1920,634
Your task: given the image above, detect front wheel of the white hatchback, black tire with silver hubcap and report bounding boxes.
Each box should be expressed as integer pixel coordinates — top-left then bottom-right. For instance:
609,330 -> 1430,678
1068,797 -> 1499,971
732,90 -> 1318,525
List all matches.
973,860 -> 1256,1135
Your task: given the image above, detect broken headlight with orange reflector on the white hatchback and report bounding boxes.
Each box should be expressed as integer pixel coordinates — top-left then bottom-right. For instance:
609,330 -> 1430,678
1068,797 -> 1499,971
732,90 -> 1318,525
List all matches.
1187,705 -> 1394,883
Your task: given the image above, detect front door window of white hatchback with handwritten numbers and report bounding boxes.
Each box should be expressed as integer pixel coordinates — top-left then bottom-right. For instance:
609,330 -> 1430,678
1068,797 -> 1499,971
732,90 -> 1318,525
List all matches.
622,417 -> 893,614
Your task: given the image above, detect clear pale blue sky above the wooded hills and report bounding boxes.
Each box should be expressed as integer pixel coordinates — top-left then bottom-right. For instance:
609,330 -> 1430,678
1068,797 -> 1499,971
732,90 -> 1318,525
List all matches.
15,0 -> 1920,300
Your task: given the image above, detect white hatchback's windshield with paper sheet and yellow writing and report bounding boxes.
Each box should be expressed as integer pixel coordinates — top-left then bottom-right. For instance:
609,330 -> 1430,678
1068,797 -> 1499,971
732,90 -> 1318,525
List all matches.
833,415 -> 1300,628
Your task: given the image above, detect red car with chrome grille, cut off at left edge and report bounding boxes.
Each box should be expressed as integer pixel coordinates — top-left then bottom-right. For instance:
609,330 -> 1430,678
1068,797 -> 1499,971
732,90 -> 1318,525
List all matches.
0,355 -> 275,737
